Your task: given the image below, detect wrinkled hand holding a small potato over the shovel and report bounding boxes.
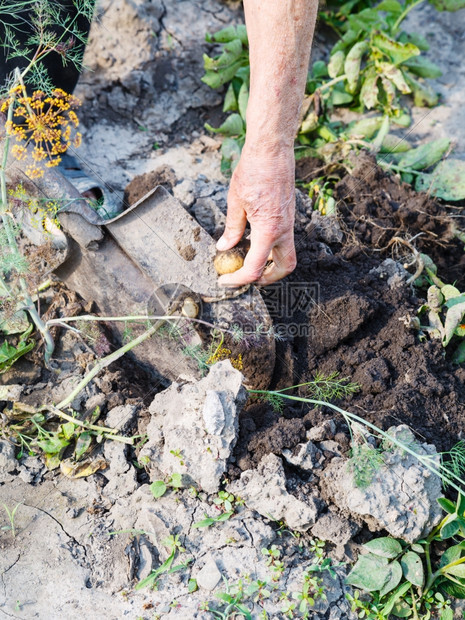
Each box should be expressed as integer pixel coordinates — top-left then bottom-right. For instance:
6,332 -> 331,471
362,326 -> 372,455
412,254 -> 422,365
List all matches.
216,147 -> 296,287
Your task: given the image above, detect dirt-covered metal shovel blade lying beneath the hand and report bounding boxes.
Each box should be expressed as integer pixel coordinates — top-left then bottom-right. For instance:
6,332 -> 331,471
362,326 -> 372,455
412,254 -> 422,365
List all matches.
57,186 -> 275,388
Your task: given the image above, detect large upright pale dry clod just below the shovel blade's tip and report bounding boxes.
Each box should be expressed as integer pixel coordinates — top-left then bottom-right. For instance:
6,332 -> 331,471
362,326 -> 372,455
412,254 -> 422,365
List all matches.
139,360 -> 246,493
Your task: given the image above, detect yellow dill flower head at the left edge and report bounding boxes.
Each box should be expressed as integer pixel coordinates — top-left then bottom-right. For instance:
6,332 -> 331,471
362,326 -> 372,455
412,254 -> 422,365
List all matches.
0,86 -> 81,178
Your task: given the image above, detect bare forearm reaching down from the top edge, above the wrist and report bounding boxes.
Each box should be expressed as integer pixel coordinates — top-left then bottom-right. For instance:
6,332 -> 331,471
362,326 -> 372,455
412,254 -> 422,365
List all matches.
244,0 -> 318,154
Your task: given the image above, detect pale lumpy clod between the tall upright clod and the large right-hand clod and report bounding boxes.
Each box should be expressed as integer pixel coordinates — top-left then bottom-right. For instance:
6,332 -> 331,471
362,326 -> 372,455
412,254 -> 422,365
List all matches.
227,454 -> 318,532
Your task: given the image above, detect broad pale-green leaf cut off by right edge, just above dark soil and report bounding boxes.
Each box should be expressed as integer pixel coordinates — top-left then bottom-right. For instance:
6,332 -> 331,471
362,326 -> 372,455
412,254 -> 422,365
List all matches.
415,159 -> 465,200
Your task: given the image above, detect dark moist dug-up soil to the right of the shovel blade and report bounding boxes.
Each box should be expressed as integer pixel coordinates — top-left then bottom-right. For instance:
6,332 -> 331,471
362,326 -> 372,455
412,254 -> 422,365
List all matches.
230,154 -> 465,476
